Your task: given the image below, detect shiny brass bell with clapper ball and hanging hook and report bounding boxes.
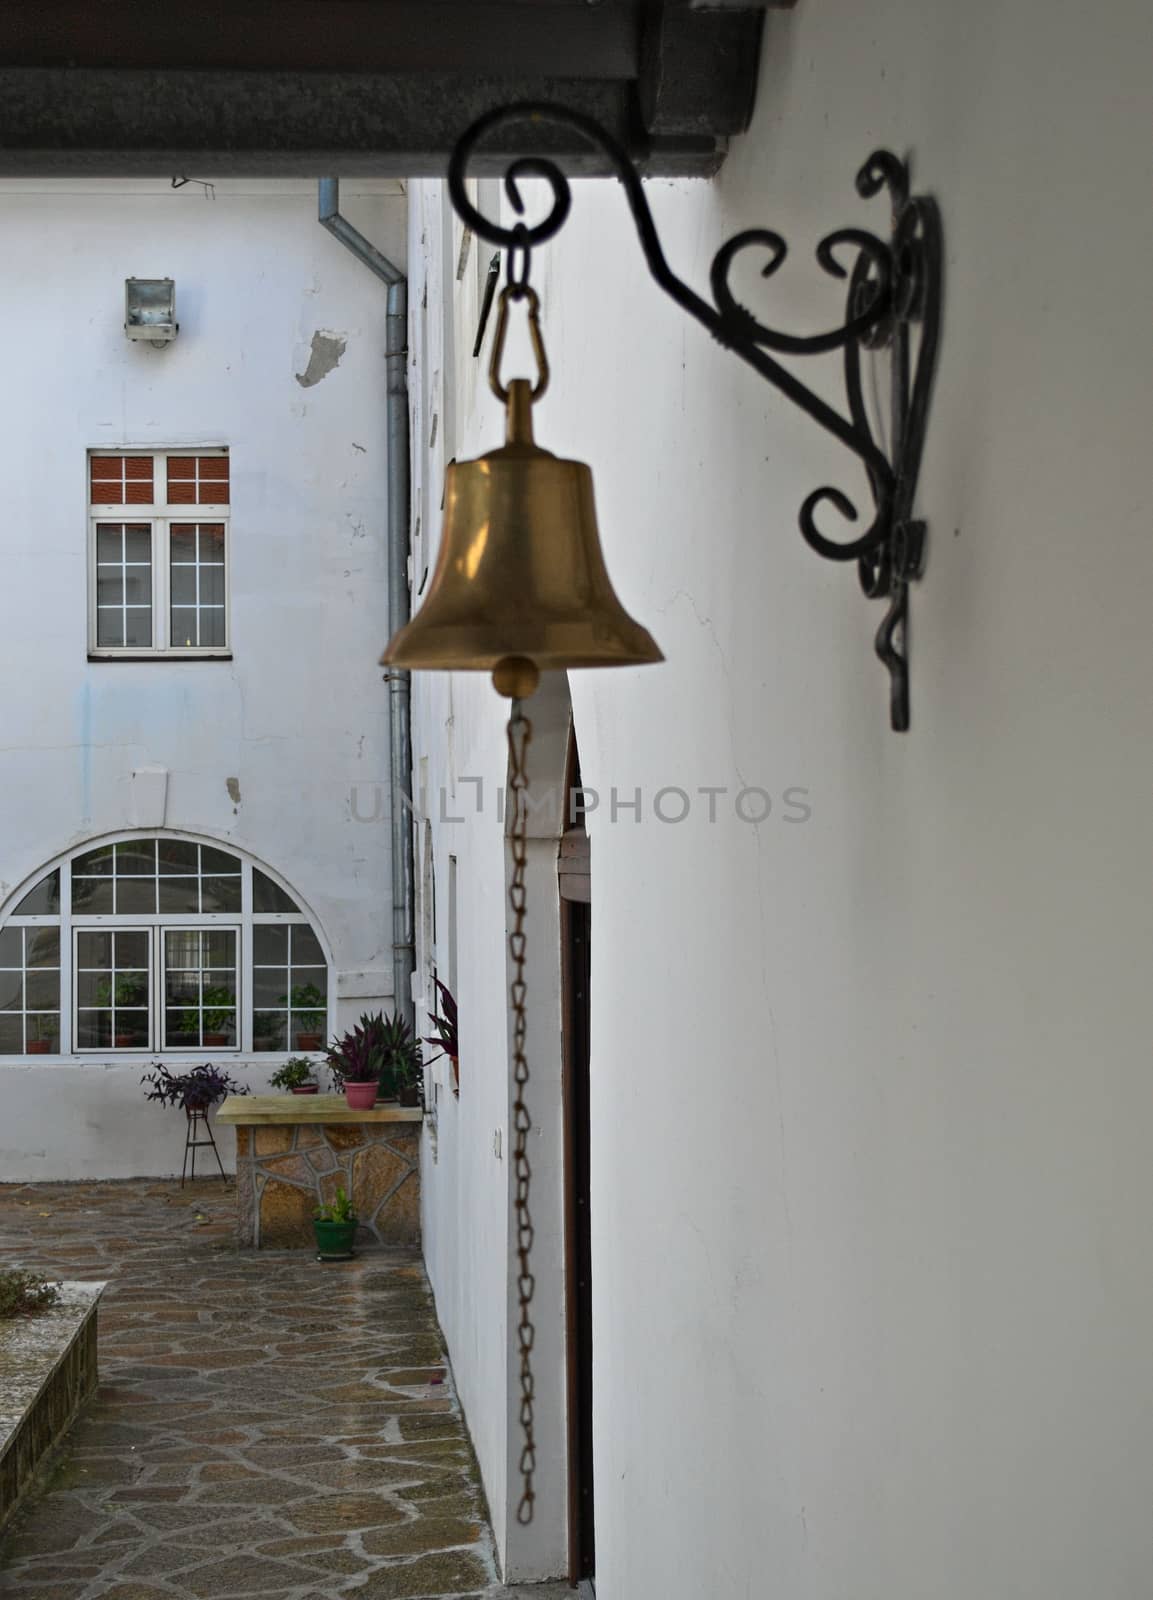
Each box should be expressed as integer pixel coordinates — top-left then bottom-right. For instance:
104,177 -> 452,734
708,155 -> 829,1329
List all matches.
381,290 -> 664,698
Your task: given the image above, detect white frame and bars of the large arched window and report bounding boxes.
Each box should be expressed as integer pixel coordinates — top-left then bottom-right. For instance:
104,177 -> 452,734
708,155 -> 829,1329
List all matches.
0,827 -> 336,1064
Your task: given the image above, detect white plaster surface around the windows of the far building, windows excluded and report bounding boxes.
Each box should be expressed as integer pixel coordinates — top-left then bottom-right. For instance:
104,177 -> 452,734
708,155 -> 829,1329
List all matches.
0,179 -> 406,1179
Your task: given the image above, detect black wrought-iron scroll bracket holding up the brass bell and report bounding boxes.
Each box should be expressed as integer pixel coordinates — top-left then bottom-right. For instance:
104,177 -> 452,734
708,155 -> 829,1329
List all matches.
448,101 -> 944,733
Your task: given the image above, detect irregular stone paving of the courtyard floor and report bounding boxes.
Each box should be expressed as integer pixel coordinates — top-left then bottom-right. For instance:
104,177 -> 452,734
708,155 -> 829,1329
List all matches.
0,1179 -> 571,1600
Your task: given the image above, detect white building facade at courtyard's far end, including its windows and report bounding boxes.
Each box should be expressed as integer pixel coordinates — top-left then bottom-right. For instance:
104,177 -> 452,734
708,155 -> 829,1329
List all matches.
0,179 -> 405,1181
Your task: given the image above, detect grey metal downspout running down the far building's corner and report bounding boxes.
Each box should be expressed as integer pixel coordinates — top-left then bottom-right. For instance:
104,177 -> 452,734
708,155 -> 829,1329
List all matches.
317,178 -> 416,1026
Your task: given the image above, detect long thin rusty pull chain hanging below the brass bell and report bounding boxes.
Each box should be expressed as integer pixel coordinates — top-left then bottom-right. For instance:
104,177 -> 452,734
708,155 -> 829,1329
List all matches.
509,699 -> 536,1525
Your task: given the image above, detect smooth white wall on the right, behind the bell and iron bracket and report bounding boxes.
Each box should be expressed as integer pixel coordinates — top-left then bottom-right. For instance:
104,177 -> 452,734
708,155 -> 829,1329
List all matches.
414,0 -> 1153,1600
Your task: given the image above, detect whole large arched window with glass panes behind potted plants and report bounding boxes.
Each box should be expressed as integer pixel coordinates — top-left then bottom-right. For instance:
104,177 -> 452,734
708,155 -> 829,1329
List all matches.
0,835 -> 331,1058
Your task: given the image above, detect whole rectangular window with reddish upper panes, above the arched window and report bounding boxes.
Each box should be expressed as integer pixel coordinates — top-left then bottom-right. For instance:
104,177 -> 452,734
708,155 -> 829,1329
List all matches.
88,450 -> 229,656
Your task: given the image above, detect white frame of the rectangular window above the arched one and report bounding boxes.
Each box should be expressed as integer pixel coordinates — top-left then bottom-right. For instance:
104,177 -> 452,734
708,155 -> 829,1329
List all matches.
85,445 -> 232,661
